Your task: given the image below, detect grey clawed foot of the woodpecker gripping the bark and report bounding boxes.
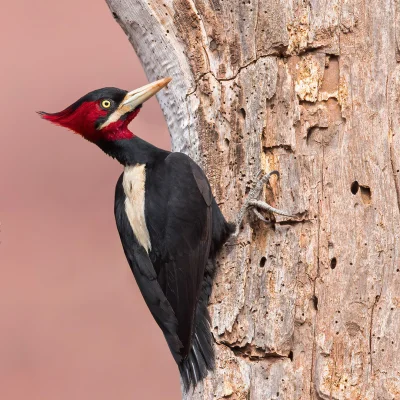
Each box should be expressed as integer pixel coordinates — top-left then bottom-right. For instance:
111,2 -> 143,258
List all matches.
233,171 -> 292,236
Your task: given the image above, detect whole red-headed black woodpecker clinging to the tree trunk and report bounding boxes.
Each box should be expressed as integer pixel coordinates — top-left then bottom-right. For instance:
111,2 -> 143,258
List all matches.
39,78 -> 290,391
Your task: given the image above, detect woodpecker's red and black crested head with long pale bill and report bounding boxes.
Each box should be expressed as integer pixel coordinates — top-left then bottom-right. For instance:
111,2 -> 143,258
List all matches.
39,78 -> 171,142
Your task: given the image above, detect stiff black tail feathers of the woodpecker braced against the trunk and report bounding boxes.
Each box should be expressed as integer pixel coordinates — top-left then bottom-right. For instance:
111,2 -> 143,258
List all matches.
179,260 -> 215,392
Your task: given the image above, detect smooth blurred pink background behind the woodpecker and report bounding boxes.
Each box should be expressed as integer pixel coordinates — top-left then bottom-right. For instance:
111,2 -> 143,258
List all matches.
0,0 -> 180,400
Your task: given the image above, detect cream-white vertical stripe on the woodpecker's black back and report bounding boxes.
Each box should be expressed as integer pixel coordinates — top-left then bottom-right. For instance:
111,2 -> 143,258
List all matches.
122,164 -> 151,253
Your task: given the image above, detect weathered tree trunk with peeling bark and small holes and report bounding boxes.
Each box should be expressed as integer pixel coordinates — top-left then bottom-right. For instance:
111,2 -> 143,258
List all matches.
107,0 -> 400,400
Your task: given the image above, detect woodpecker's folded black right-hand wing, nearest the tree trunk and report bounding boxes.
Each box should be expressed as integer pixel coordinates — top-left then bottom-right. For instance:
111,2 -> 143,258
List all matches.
163,153 -> 212,357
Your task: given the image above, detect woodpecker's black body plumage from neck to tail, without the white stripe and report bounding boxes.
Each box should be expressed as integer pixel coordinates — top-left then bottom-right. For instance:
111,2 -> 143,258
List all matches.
108,137 -> 235,389
